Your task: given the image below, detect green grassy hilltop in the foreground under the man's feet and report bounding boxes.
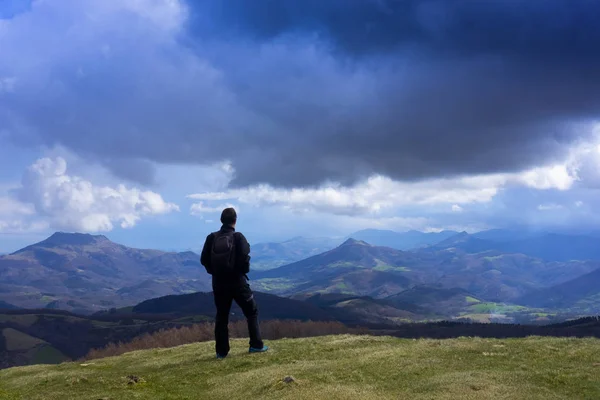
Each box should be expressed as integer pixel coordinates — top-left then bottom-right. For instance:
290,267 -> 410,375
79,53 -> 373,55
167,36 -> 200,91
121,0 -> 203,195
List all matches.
0,335 -> 600,400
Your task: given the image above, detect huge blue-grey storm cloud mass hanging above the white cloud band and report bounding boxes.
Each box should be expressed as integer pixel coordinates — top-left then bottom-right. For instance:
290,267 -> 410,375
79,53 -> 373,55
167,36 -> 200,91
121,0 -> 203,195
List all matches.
0,0 -> 600,186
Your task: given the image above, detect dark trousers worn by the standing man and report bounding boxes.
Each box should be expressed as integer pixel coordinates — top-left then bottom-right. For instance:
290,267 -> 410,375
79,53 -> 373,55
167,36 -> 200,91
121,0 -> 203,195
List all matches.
213,284 -> 264,356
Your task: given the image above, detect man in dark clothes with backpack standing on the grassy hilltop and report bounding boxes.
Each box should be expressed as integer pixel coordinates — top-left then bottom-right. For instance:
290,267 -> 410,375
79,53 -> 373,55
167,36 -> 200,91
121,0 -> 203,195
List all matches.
200,208 -> 269,359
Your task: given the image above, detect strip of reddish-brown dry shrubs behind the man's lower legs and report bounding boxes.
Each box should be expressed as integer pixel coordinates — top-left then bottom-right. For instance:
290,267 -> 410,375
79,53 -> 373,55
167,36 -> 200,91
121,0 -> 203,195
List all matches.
85,320 -> 368,360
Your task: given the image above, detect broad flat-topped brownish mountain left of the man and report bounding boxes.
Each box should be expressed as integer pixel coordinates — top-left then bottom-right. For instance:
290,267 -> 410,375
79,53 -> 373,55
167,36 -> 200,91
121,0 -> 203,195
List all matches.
0,233 -> 211,313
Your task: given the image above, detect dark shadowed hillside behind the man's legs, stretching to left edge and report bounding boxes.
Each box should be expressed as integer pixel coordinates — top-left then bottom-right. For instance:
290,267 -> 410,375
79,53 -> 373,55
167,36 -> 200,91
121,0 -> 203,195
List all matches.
0,292 -> 338,368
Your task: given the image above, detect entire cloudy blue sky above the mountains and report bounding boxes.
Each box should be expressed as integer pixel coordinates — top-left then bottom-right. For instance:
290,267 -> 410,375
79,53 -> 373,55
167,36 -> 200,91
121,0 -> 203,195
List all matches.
0,0 -> 600,251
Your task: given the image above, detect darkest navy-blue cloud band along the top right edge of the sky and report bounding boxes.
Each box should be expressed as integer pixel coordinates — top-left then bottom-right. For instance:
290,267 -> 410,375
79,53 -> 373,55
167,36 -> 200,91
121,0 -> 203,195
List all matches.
196,0 -> 600,62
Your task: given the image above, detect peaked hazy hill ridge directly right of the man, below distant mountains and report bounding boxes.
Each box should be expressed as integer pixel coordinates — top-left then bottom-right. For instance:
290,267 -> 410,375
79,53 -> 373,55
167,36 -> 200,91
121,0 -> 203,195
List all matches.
251,235 -> 600,304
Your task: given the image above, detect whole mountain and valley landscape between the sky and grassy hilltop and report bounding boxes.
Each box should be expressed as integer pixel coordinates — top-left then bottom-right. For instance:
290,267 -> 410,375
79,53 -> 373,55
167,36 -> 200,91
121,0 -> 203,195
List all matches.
0,231 -> 600,367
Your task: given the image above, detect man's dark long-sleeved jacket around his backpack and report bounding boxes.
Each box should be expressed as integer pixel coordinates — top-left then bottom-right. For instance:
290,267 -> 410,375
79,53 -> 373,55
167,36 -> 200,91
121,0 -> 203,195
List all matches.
200,225 -> 250,287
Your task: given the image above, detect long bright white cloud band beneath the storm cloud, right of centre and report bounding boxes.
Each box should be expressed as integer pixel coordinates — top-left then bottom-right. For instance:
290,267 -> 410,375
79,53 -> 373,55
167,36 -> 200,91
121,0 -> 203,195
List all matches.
188,136 -> 600,220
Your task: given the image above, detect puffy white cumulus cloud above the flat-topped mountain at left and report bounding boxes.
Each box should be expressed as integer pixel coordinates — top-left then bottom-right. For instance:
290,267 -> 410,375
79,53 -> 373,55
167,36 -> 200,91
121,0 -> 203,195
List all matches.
19,157 -> 179,232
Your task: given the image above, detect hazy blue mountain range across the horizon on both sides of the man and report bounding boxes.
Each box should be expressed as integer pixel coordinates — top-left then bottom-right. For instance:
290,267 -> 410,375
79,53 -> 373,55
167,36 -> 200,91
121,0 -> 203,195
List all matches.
0,230 -> 600,319
